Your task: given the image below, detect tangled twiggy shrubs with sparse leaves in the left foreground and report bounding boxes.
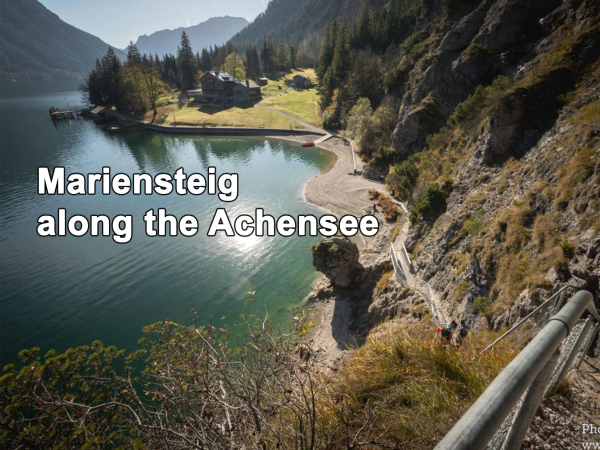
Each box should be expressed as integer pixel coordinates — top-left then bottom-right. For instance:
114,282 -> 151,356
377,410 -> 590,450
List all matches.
0,314 -> 326,449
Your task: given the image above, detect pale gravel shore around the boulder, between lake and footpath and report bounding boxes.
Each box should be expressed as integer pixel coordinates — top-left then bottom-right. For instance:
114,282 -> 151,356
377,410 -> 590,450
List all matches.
278,136 -> 427,369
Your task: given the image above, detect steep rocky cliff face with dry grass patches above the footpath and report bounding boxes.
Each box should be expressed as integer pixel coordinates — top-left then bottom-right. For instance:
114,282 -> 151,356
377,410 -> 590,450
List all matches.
384,0 -> 600,328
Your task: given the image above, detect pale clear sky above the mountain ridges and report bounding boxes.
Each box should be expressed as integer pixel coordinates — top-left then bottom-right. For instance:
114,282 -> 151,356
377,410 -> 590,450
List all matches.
40,0 -> 269,48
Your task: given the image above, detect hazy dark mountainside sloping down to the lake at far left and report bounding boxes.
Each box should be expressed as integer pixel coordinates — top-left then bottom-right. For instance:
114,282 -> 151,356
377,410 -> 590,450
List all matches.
0,0 -> 124,79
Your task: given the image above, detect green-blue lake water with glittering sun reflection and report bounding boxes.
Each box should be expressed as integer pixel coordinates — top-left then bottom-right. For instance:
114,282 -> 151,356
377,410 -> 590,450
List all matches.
0,83 -> 333,364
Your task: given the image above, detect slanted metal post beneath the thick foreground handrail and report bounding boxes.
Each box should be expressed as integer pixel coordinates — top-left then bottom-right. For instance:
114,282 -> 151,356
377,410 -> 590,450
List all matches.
502,350 -> 560,450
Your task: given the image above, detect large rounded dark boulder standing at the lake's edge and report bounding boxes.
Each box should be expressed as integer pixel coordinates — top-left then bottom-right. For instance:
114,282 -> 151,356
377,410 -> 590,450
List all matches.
312,236 -> 361,287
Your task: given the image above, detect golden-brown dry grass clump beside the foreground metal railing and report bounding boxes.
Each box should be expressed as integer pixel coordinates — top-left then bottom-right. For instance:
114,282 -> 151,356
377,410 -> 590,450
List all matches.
323,322 -> 516,449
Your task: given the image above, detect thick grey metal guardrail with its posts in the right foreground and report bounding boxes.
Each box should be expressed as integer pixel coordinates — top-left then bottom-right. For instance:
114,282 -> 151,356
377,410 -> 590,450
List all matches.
435,291 -> 600,450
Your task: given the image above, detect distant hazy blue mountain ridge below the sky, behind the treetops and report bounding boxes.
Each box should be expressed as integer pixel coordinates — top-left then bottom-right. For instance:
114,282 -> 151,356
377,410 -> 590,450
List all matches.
135,16 -> 248,56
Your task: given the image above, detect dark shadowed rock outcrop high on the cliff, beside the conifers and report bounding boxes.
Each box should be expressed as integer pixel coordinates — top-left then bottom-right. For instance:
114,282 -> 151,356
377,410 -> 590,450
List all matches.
393,0 -> 578,157
